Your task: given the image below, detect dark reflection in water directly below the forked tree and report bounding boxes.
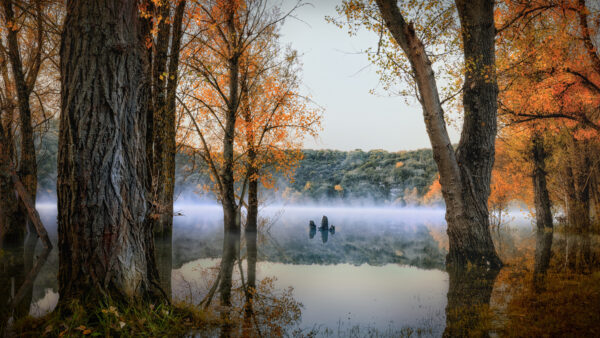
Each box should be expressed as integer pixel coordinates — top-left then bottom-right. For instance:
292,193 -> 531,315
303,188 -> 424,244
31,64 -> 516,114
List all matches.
444,267 -> 500,337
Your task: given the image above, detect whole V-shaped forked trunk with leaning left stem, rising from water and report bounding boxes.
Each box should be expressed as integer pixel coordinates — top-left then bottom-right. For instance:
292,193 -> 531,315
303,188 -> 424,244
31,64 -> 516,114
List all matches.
376,0 -> 502,267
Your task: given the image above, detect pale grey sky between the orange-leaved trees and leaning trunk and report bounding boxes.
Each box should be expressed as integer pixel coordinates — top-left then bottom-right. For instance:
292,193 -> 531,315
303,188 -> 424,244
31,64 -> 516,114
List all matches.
274,0 -> 459,151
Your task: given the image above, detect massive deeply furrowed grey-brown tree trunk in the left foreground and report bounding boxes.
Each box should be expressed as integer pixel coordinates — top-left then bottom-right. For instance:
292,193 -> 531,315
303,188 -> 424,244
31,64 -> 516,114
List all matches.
57,0 -> 160,304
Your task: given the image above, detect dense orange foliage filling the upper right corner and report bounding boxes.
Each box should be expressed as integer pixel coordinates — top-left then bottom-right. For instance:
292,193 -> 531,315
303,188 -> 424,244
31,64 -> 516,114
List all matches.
496,0 -> 600,136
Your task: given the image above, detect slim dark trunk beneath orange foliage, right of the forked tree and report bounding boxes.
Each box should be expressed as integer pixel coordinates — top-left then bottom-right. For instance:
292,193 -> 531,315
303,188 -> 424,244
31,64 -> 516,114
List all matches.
532,134 -> 552,230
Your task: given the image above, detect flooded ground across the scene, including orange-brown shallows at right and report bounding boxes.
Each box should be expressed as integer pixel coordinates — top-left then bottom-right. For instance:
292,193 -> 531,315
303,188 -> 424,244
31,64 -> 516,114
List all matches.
0,205 -> 600,336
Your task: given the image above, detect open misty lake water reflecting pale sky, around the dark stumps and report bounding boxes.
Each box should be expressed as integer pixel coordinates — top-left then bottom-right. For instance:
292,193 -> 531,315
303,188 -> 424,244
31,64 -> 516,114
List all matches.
0,205 -> 592,336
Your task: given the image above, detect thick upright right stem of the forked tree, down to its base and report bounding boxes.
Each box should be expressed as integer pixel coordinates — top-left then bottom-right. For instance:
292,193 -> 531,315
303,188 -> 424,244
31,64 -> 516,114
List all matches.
446,0 -> 502,267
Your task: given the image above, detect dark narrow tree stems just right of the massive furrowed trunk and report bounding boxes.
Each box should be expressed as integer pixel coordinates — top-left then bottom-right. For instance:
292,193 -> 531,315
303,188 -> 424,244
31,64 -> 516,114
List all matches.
141,0 -> 187,234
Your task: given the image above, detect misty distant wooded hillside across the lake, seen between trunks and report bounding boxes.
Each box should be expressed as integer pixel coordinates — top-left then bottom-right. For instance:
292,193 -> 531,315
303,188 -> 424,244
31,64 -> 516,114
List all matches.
36,121 -> 439,205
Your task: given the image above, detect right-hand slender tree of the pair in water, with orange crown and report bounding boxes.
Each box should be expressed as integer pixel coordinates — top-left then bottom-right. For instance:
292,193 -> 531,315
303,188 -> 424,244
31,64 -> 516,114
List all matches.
238,48 -> 322,304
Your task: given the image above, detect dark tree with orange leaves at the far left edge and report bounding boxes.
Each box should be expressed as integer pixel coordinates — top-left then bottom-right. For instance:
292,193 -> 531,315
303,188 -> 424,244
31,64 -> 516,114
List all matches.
0,0 -> 55,236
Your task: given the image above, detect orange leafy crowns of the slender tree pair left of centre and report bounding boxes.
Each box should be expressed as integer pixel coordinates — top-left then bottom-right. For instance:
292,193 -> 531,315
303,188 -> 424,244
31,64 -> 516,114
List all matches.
180,0 -> 320,203
